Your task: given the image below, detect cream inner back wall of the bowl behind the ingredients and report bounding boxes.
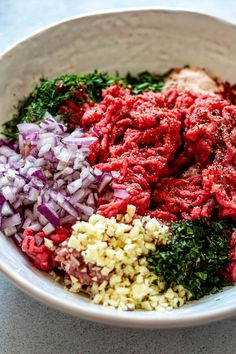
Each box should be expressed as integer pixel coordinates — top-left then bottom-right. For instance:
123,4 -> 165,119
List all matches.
0,11 -> 236,120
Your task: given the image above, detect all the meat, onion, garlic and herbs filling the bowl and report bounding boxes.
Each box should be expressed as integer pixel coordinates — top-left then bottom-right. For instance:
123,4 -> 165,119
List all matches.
0,68 -> 236,310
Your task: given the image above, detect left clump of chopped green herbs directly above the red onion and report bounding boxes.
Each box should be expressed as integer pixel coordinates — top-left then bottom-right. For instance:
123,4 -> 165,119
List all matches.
2,71 -> 118,139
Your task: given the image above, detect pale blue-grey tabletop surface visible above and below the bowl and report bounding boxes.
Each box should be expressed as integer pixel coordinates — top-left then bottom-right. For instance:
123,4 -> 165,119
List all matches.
0,0 -> 236,354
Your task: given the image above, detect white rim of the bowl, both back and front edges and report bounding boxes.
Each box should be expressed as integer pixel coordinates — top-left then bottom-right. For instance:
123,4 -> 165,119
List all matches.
0,6 -> 236,328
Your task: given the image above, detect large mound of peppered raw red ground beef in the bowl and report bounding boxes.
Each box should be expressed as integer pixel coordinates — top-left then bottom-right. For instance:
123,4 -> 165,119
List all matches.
82,85 -> 236,221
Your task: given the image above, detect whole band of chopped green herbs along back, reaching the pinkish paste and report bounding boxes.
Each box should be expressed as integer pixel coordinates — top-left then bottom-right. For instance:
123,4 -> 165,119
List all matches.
2,71 -> 163,139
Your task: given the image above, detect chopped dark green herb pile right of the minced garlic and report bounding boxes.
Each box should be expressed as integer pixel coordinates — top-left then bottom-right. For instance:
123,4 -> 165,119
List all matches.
149,219 -> 233,299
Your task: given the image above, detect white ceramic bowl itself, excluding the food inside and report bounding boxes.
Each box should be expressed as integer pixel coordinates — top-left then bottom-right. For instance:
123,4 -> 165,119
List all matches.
0,9 -> 236,328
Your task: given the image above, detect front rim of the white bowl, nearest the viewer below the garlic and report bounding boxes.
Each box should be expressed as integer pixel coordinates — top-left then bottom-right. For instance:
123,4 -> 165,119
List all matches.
0,253 -> 236,328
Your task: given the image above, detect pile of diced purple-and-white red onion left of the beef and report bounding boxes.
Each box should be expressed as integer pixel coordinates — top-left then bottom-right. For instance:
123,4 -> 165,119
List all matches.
0,119 -> 113,243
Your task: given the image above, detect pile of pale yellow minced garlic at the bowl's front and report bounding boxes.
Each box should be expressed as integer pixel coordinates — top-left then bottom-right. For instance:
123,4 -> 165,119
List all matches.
54,205 -> 190,310
